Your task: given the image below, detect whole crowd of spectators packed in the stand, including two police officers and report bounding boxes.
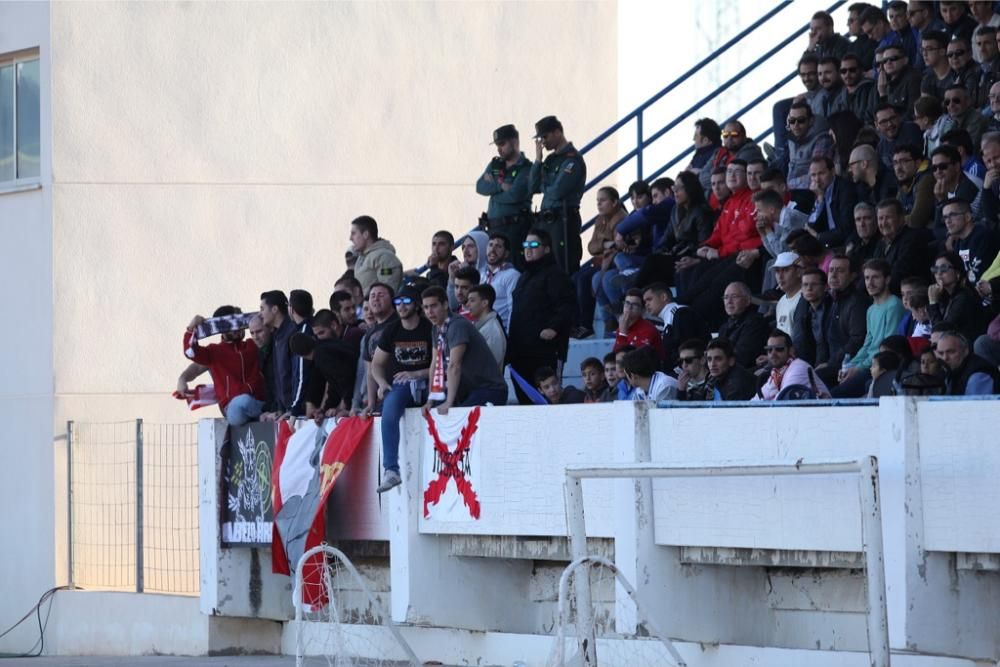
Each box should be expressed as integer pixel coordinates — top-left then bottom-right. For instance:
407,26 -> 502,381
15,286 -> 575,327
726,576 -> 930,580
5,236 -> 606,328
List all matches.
178,1 -> 1000,491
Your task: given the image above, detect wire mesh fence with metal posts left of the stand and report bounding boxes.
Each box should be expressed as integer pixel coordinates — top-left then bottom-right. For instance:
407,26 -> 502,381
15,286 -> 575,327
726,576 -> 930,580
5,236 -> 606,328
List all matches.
67,419 -> 199,595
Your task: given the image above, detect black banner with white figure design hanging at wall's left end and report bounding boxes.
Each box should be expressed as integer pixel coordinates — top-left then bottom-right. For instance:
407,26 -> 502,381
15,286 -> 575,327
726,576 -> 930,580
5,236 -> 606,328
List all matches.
222,422 -> 277,547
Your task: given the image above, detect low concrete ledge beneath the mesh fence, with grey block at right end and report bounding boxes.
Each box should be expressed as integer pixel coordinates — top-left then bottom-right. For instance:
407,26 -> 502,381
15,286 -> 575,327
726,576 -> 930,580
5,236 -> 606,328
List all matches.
45,590 -> 281,656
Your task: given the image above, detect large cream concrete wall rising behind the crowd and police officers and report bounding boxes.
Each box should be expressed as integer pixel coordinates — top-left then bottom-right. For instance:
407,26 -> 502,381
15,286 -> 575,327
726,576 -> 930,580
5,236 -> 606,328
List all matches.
52,2 -> 617,434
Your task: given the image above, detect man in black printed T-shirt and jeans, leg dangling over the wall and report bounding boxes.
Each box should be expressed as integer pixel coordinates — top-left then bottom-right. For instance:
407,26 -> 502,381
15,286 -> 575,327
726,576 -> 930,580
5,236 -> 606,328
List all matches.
366,286 -> 430,493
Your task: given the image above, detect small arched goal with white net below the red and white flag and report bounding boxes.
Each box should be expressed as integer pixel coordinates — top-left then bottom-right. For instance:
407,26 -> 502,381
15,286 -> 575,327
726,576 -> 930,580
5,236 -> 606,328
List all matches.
293,545 -> 421,667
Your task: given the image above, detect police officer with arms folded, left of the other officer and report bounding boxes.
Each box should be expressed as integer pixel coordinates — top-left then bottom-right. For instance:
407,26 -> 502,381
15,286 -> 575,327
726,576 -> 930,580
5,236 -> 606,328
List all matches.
476,125 -> 532,268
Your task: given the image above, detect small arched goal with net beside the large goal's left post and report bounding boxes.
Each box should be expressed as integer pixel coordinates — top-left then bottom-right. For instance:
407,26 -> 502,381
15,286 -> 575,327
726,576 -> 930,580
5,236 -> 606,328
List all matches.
545,556 -> 686,667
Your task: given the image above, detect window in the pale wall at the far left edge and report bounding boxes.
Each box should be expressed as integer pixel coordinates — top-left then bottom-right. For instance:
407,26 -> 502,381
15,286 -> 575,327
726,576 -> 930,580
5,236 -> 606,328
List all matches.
0,55 -> 41,183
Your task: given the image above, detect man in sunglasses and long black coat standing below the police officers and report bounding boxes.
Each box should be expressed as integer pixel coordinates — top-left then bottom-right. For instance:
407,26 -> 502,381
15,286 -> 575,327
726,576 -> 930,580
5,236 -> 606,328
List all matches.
507,228 -> 576,405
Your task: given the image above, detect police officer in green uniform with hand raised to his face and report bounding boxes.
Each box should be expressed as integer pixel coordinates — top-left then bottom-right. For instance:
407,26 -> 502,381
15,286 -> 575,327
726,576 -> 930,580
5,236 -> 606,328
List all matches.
531,116 -> 587,273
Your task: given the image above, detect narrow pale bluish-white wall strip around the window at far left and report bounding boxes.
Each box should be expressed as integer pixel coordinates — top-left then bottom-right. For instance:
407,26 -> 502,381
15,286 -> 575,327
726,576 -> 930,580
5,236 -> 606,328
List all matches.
0,2 -> 53,653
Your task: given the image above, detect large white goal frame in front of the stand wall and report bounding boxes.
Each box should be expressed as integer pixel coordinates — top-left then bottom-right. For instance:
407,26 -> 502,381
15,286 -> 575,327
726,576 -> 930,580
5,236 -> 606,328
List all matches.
560,456 -> 890,667
